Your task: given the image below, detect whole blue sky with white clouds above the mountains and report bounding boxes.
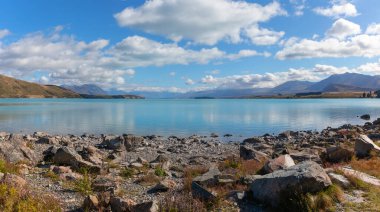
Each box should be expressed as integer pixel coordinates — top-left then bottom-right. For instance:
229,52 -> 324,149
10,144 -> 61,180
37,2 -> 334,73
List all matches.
0,0 -> 380,92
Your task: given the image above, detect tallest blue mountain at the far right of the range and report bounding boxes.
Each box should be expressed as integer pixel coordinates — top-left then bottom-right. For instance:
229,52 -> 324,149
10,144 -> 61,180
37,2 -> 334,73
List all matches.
308,73 -> 380,91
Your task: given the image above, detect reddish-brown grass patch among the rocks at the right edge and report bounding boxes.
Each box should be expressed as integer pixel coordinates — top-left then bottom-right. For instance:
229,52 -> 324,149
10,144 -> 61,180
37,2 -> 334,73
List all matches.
350,157 -> 380,178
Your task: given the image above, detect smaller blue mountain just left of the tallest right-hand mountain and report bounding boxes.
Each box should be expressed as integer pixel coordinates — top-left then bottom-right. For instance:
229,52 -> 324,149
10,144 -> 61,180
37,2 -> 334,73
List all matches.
270,81 -> 315,94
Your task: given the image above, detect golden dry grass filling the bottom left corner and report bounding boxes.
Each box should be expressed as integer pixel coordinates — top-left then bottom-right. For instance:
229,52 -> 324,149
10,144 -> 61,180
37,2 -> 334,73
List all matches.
0,184 -> 61,212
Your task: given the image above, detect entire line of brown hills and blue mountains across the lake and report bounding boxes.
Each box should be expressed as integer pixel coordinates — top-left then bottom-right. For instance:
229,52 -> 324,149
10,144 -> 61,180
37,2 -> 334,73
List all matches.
0,73 -> 380,99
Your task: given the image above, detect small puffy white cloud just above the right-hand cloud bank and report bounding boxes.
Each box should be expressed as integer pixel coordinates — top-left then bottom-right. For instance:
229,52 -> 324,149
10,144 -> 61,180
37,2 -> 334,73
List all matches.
327,18 -> 361,40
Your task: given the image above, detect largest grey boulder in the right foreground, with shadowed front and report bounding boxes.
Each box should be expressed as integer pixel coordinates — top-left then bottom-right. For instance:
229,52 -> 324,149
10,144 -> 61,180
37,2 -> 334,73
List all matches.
250,161 -> 331,207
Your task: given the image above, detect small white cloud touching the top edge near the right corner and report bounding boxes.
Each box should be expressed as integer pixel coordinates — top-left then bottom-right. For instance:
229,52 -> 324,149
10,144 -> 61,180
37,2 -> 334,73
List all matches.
314,1 -> 359,18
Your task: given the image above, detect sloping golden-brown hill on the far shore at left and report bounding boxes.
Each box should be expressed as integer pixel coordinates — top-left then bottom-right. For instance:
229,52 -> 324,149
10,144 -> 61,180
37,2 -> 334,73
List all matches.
0,75 -> 80,98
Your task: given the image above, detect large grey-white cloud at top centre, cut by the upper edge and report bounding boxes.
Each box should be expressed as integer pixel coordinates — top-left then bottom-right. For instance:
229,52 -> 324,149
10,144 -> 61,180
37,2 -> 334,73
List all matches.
115,0 -> 286,45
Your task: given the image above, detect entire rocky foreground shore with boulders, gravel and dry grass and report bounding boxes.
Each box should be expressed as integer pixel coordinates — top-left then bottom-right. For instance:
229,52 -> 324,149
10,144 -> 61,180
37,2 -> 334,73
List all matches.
0,119 -> 380,211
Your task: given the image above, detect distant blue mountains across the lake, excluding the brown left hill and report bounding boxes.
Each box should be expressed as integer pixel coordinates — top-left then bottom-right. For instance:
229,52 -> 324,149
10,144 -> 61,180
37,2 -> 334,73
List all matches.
63,73 -> 380,99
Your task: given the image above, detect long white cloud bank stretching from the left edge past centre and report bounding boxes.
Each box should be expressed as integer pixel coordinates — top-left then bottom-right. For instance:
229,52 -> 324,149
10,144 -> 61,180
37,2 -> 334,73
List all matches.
0,30 -> 261,88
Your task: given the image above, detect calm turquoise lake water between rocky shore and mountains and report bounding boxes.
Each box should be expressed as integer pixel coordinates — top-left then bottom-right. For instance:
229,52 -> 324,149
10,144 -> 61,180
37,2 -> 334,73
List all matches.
0,99 -> 380,137
